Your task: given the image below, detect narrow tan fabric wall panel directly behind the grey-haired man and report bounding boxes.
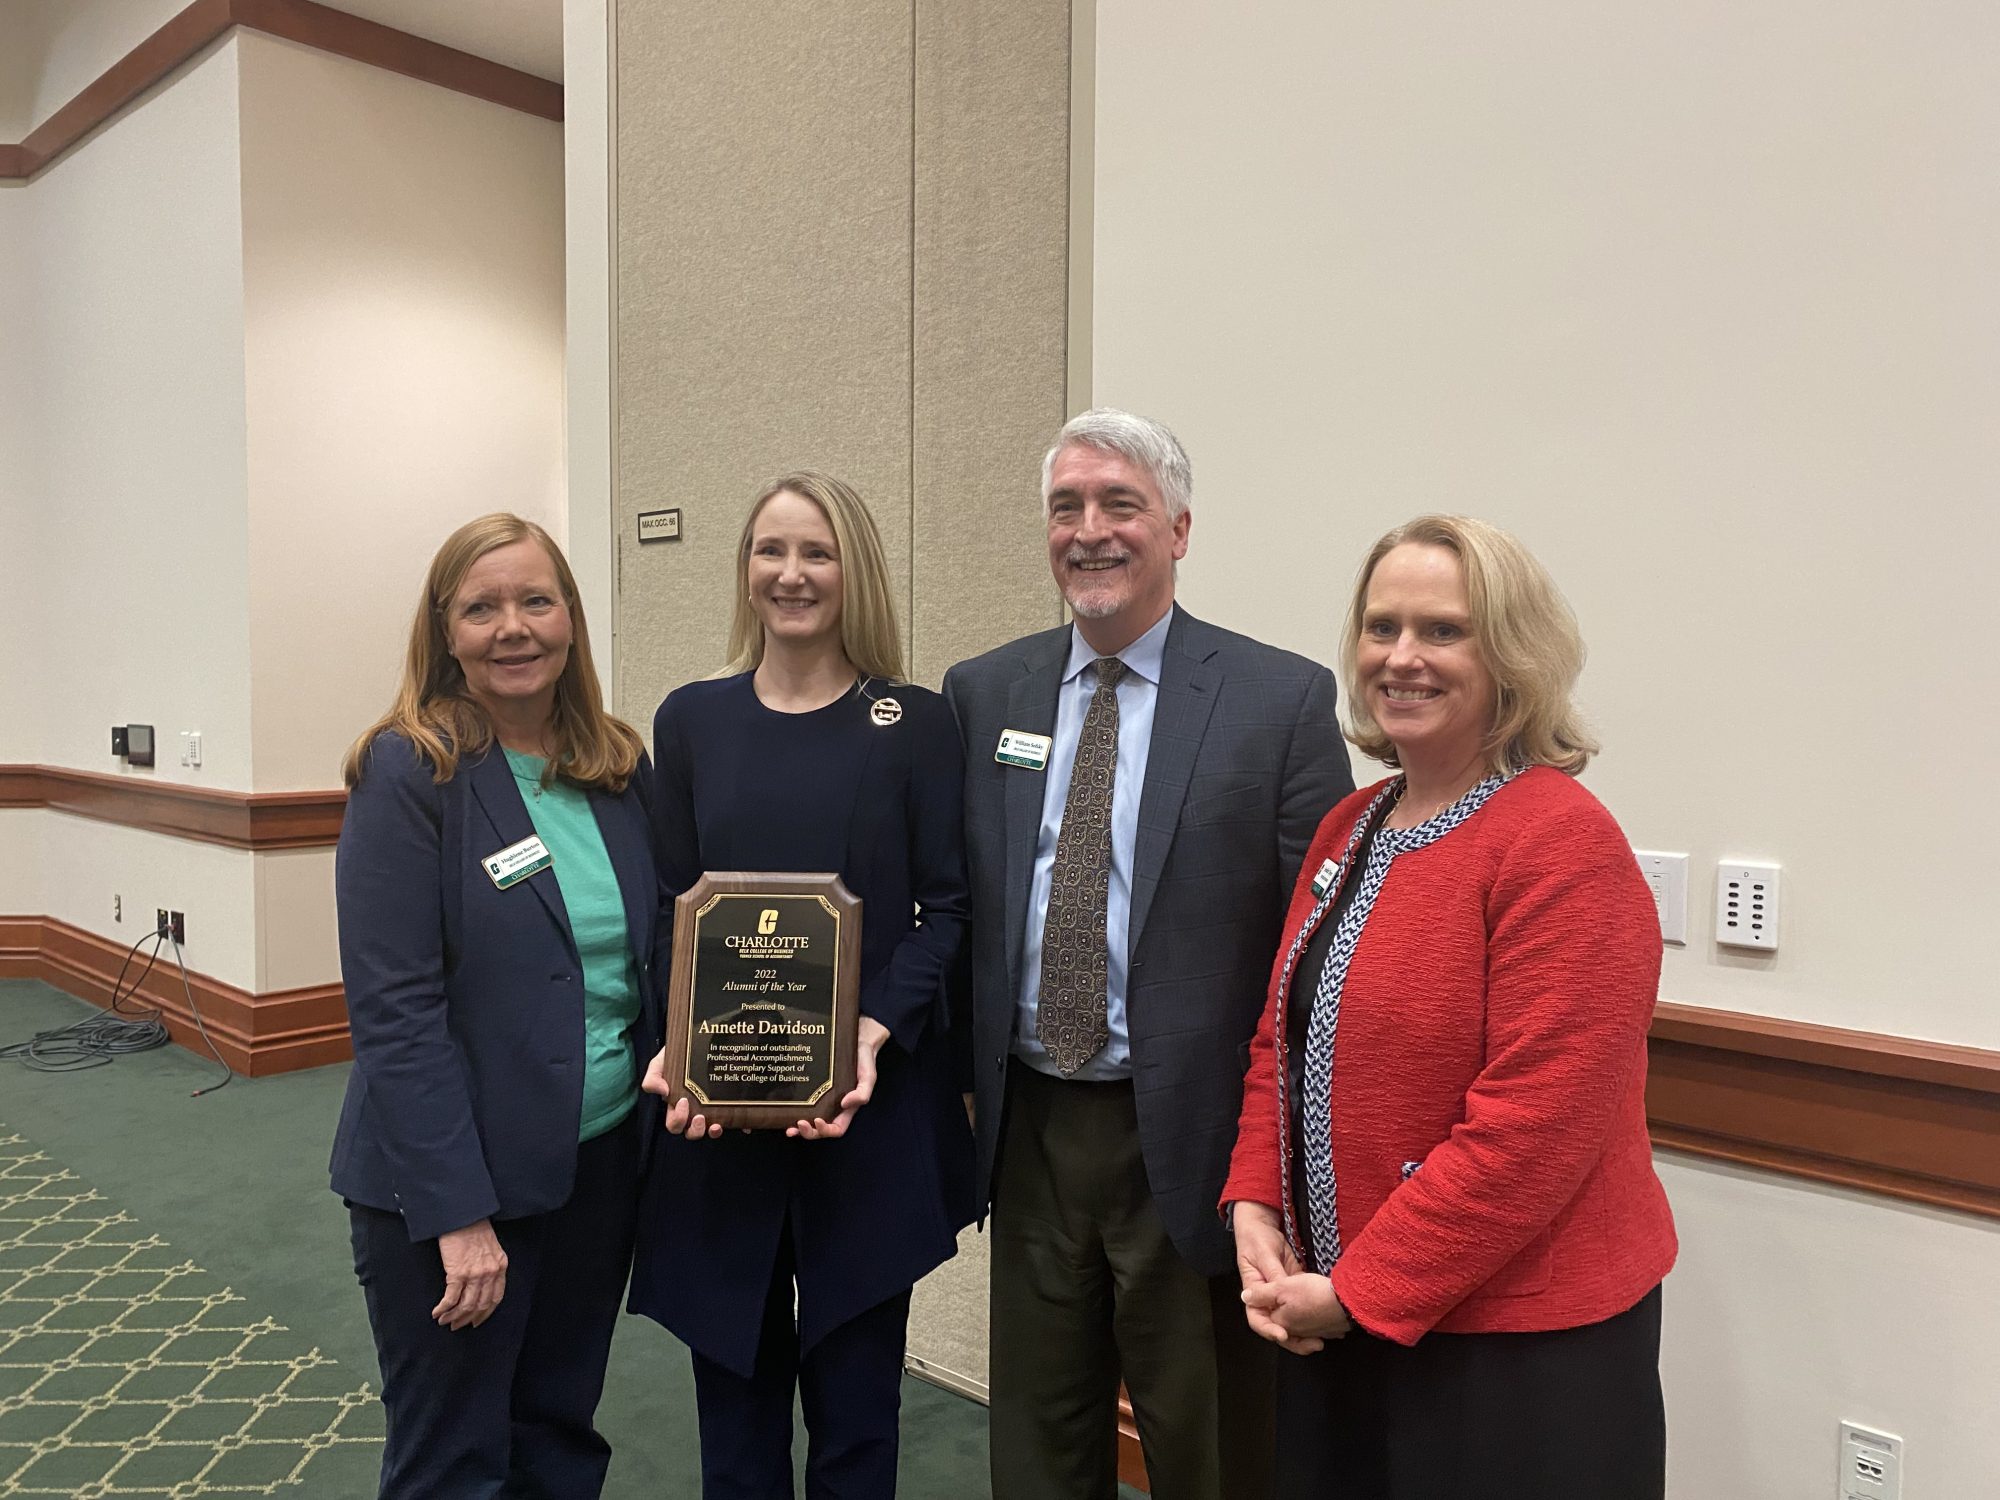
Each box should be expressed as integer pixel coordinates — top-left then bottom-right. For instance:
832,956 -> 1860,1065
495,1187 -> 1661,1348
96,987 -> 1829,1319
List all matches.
910,0 -> 1070,684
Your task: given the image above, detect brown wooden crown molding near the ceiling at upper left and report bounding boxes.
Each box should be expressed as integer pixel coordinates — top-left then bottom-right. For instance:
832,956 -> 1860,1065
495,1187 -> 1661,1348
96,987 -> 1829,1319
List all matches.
0,0 -> 562,178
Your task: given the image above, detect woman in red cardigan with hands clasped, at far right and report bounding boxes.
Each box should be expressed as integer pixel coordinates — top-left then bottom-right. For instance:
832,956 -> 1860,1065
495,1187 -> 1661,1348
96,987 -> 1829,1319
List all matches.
1224,516 -> 1674,1500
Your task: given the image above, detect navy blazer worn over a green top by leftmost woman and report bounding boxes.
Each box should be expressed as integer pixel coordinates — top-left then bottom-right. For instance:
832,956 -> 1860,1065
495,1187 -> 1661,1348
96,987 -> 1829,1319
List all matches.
330,734 -> 660,1240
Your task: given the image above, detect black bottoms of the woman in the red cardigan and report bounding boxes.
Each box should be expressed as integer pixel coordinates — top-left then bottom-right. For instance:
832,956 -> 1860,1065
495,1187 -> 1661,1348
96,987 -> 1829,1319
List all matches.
1278,1286 -> 1666,1500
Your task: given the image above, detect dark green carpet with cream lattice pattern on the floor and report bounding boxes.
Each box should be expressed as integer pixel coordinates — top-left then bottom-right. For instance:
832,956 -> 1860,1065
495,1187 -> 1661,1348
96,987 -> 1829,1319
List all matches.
0,980 -> 988,1500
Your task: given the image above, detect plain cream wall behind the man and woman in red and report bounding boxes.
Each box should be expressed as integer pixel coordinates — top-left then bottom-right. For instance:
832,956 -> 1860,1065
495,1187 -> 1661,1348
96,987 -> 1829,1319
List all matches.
1092,0 -> 2000,1500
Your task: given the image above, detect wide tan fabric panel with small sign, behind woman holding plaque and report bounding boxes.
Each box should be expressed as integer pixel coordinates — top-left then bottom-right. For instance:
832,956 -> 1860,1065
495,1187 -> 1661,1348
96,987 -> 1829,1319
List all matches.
616,0 -> 912,724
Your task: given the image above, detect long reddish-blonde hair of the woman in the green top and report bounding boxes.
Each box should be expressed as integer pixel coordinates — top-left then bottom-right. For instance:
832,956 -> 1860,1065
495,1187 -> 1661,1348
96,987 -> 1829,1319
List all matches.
340,512 -> 644,792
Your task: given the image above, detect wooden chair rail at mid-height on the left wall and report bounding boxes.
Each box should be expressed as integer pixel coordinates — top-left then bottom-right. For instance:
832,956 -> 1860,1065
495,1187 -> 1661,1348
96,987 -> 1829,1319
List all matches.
0,766 -> 348,850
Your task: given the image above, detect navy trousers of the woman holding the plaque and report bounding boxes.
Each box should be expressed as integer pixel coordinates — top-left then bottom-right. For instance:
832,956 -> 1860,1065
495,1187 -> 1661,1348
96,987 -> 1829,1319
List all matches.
694,1226 -> 910,1500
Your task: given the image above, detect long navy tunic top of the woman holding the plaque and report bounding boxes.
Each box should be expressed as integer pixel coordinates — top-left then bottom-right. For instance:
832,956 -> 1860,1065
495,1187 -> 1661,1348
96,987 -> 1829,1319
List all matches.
632,674 -> 976,1376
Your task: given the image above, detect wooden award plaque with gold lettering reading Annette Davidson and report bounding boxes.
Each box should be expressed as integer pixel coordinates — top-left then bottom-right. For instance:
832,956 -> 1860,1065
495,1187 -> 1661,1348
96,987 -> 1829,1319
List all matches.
666,870 -> 862,1130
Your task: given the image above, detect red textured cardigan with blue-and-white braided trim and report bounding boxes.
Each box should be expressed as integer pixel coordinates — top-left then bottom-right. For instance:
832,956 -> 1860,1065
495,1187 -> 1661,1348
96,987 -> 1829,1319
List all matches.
1222,766 -> 1676,1344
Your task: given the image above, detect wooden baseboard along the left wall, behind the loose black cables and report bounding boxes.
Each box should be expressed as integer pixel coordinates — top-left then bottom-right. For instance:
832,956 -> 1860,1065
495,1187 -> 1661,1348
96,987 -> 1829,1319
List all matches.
0,916 -> 354,1078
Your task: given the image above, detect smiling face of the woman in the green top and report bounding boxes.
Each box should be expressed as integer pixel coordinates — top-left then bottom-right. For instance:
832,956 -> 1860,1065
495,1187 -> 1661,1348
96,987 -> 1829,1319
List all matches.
444,540 -> 574,716
